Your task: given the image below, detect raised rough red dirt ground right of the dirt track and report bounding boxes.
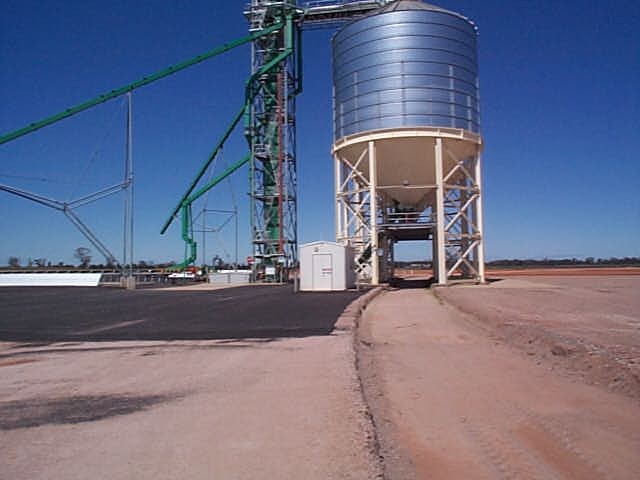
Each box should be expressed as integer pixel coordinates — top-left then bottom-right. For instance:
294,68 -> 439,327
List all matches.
436,276 -> 640,399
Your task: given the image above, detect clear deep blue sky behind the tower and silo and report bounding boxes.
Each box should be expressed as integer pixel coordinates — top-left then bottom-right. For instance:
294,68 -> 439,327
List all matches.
0,0 -> 640,264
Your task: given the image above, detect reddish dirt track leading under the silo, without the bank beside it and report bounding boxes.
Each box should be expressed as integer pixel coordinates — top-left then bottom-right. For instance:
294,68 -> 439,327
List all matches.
359,289 -> 640,480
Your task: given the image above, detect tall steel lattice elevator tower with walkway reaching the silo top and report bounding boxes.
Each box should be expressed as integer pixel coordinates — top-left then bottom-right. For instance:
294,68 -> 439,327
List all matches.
245,0 -> 386,280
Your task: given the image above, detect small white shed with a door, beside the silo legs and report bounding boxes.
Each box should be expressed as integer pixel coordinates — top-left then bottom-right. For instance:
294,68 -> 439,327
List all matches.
300,242 -> 356,291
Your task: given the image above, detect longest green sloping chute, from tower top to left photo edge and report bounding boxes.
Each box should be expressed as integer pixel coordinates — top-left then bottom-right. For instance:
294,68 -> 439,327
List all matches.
0,23 -> 283,145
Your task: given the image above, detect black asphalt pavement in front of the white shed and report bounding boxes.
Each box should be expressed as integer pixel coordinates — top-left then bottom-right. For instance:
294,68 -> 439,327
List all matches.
0,285 -> 362,343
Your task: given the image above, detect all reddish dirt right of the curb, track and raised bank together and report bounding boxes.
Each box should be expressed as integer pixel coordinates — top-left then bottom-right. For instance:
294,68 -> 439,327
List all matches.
358,276 -> 640,480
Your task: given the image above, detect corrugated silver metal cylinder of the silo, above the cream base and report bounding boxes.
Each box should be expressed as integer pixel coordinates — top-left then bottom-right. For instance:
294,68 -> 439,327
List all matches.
333,1 -> 480,139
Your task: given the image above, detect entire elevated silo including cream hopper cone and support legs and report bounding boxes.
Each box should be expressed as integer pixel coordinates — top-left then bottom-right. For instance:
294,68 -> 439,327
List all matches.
333,0 -> 484,283
